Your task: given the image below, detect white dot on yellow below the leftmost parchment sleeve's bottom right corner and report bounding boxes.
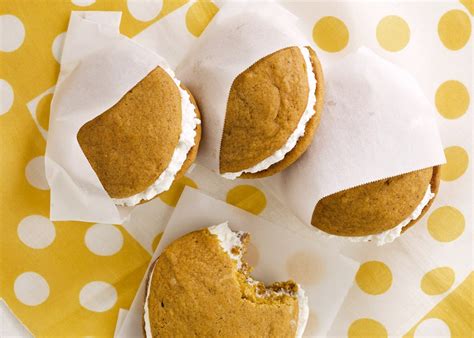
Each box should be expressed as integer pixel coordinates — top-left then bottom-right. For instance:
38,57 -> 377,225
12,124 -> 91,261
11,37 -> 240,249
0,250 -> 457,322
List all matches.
84,223 -> 123,256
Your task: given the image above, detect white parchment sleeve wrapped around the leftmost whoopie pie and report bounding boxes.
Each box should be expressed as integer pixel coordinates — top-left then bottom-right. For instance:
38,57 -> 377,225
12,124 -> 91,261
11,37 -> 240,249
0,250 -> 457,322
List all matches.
45,12 -> 164,223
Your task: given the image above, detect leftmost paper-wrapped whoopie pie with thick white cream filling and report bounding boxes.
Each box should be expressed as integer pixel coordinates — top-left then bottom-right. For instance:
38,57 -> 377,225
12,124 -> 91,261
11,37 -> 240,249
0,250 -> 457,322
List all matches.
77,67 -> 201,206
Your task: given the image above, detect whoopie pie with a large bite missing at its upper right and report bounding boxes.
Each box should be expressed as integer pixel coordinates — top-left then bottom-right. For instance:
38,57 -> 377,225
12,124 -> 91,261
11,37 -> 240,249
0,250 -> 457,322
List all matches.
143,223 -> 308,337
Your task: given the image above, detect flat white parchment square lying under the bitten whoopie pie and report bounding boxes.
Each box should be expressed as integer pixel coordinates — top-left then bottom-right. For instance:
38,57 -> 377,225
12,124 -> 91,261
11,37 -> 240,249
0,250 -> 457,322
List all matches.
115,188 -> 358,337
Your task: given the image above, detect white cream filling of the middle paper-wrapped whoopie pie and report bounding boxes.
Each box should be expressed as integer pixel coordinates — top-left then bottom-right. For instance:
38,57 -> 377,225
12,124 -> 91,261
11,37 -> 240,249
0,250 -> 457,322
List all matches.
221,47 -> 316,180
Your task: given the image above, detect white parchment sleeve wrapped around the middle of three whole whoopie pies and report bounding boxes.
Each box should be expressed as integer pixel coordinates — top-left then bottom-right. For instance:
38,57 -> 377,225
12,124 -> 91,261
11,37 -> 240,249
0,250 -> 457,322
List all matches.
176,1 -> 309,173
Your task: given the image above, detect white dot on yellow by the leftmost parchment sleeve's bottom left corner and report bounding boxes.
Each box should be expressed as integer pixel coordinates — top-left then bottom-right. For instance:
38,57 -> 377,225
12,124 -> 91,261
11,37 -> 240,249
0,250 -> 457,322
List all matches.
17,215 -> 56,249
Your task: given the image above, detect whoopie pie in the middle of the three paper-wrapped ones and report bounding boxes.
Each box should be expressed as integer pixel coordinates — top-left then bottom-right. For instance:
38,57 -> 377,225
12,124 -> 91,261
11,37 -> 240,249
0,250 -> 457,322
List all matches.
220,47 -> 324,179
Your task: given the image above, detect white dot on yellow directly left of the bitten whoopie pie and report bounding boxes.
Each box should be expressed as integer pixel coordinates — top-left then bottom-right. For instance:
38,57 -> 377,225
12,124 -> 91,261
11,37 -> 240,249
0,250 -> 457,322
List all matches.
79,282 -> 117,312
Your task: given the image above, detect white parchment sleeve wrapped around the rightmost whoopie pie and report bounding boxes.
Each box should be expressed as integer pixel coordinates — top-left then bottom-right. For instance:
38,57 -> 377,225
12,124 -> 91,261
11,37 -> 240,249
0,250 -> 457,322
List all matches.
266,48 -> 445,224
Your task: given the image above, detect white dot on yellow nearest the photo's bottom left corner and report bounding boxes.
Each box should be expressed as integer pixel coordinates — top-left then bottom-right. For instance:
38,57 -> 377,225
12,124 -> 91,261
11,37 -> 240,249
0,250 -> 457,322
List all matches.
13,272 -> 49,306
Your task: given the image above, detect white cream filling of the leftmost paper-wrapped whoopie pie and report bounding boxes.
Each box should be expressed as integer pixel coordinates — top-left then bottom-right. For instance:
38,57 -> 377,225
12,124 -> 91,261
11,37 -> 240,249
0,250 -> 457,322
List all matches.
112,67 -> 201,206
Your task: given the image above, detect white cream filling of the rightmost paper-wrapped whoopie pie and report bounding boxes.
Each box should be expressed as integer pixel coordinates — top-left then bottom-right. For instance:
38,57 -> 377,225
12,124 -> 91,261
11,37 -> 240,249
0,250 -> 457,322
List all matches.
314,184 -> 435,246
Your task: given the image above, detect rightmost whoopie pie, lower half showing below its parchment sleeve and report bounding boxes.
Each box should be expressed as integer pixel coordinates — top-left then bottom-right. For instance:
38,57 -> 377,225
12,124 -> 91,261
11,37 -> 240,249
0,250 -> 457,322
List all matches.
311,167 -> 440,245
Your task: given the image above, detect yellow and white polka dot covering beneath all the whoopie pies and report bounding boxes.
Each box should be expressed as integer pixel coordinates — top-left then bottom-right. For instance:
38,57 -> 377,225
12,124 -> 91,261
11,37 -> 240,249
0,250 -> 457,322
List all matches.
0,0 -> 474,337
